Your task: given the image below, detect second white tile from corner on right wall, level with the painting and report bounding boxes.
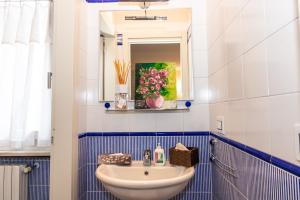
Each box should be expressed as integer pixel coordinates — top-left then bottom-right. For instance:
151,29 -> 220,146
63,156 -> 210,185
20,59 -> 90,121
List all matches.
228,57 -> 244,99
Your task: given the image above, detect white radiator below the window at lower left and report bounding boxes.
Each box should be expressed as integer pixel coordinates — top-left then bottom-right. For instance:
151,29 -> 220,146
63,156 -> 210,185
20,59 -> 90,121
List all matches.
0,165 -> 28,200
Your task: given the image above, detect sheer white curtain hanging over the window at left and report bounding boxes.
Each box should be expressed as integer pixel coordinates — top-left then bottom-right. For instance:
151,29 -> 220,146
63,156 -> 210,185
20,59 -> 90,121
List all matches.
0,0 -> 52,150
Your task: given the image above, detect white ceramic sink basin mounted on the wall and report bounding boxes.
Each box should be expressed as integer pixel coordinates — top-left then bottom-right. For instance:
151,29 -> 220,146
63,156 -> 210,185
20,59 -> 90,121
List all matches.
96,161 -> 195,200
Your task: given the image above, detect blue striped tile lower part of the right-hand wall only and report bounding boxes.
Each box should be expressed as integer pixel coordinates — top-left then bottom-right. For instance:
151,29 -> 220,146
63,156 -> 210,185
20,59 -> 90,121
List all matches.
211,135 -> 300,200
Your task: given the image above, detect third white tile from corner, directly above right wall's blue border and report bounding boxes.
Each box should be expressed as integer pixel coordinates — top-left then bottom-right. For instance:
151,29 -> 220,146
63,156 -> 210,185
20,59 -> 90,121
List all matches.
245,97 -> 271,153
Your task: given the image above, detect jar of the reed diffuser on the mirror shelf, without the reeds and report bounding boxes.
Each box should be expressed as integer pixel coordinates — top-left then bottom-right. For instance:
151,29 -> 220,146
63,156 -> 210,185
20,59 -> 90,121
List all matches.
115,85 -> 128,110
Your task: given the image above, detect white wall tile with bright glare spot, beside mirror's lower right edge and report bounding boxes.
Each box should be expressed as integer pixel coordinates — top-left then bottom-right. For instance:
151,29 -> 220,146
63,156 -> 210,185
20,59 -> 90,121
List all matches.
194,78 -> 208,103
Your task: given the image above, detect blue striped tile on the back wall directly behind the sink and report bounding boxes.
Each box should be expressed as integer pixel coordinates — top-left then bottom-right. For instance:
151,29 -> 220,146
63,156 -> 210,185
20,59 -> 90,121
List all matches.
78,132 -> 212,200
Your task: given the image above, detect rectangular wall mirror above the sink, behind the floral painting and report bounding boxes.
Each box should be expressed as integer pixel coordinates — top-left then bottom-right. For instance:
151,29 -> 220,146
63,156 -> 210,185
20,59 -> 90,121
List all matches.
99,5 -> 193,104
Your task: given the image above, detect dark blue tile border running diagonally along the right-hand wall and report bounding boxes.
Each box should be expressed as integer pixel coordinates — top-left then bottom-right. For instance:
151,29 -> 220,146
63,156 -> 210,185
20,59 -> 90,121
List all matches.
210,133 -> 300,177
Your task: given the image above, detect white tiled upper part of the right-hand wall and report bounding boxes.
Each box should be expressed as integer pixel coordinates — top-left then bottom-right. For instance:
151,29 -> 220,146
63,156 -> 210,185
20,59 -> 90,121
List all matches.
207,0 -> 300,165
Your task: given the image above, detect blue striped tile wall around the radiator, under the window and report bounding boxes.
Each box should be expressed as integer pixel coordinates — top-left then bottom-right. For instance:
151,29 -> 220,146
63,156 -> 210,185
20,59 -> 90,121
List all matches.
0,157 -> 50,200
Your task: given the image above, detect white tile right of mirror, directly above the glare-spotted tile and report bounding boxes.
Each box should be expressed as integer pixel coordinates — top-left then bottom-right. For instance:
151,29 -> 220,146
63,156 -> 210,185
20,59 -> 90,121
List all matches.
193,51 -> 208,78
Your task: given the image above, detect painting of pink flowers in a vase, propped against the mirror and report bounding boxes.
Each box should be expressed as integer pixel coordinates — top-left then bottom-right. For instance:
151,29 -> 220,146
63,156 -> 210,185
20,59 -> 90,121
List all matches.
135,63 -> 177,109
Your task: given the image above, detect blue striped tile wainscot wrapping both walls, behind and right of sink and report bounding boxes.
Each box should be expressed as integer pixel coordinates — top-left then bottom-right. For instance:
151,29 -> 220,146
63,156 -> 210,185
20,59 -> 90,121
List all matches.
78,132 -> 300,200
